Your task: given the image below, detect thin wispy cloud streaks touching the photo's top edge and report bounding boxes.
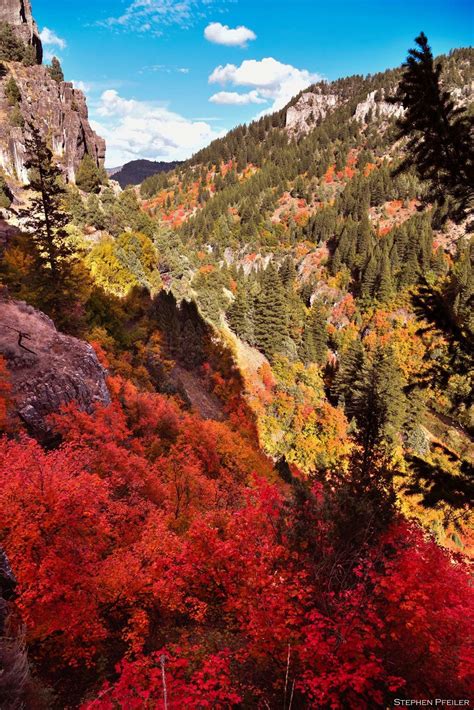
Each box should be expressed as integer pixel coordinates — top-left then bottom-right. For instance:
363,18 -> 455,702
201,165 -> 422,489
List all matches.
98,0 -> 227,36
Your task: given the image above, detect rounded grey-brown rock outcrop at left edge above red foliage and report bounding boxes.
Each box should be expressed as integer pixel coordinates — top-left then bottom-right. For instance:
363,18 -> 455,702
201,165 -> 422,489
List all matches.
0,296 -> 110,441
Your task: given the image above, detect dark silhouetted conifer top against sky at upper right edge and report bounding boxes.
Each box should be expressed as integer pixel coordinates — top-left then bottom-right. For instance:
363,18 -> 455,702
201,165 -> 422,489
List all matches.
393,32 -> 474,216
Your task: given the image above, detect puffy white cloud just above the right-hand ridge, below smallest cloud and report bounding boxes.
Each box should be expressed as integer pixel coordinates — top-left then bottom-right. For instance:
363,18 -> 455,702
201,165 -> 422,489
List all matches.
209,57 -> 321,113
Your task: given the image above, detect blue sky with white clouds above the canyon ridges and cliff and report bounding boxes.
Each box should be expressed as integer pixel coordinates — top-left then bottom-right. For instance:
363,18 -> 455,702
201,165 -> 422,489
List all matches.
33,0 -> 474,166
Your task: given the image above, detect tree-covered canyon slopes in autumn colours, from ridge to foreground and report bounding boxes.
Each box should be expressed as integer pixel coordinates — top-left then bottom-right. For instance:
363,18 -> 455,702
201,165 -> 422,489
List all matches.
0,29 -> 474,710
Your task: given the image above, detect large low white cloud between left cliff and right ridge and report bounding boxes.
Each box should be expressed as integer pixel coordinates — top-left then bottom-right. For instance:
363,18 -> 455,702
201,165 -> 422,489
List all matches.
91,89 -> 224,165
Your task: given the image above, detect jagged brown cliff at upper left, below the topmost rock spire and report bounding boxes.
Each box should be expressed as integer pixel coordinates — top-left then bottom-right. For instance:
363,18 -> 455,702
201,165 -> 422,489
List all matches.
0,63 -> 105,184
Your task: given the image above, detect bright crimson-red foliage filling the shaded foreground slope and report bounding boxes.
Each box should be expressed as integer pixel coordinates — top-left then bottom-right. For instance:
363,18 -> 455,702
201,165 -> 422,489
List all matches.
0,372 -> 473,710
